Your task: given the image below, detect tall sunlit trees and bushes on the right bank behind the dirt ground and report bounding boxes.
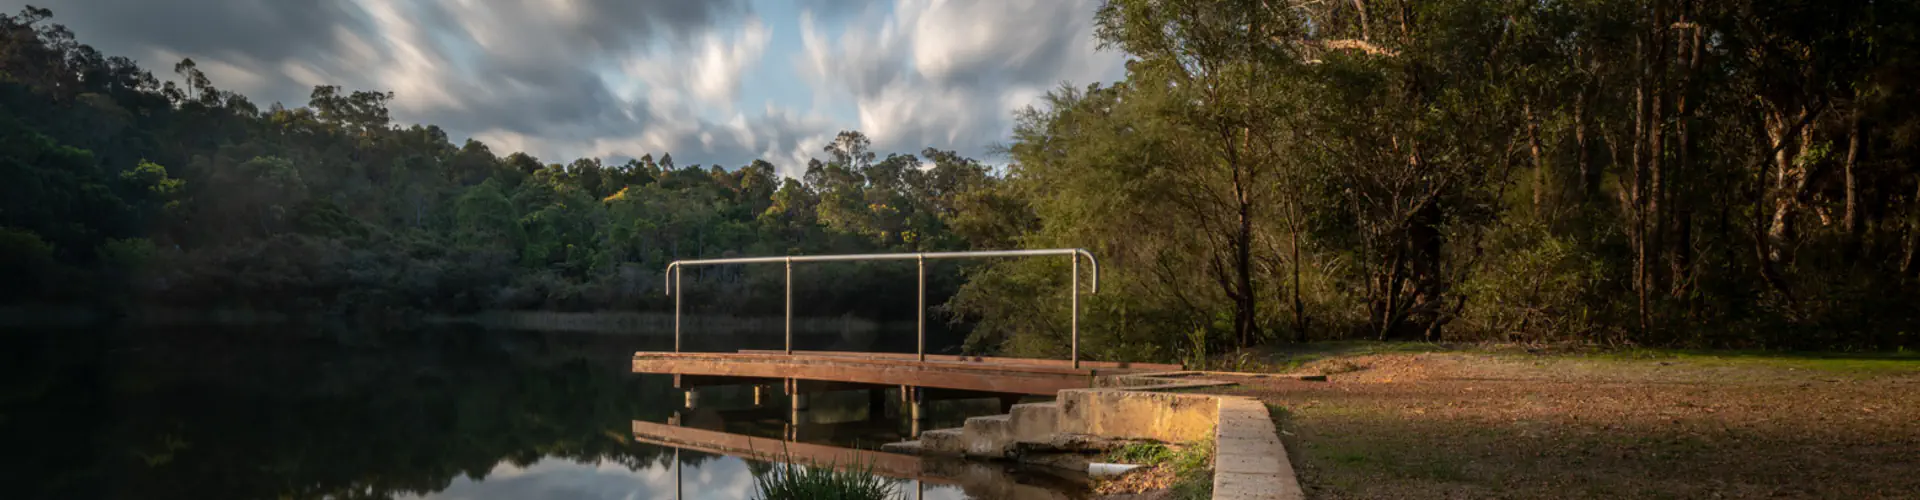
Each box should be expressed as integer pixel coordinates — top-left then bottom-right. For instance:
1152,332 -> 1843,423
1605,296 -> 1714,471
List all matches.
950,0 -> 1920,355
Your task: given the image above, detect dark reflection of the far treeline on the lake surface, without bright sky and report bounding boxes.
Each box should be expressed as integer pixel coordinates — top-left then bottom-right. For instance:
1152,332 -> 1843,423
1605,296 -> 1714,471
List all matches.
0,333 -> 691,498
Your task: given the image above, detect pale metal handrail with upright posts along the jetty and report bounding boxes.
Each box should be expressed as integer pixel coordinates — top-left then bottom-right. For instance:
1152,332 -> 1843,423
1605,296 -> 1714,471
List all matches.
666,248 -> 1100,369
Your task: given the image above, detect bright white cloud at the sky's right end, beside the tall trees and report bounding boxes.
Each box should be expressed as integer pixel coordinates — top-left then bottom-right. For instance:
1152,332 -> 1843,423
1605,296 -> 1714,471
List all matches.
797,0 -> 1123,154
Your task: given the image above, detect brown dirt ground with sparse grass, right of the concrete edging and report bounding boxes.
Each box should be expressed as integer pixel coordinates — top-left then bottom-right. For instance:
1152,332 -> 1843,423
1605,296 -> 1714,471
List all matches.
1219,352 -> 1920,498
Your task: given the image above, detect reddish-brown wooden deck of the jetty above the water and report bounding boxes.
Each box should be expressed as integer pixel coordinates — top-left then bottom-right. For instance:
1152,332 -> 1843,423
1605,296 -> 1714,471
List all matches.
634,350 -> 1179,396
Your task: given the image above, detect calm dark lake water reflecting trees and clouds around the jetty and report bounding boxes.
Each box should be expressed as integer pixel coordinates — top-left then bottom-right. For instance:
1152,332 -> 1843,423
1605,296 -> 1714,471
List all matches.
0,327 -> 1077,498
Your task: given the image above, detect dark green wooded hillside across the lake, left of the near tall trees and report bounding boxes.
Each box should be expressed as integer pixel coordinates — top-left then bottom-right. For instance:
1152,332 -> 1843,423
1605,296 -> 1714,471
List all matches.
0,10 -> 1023,315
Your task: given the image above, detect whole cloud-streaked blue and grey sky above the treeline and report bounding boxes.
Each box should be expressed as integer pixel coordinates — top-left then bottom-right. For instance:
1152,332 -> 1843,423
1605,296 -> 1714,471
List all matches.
11,0 -> 1125,175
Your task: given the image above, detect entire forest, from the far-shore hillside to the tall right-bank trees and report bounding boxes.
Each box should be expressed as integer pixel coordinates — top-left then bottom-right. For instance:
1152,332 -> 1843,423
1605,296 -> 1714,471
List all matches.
0,0 -> 1920,360
